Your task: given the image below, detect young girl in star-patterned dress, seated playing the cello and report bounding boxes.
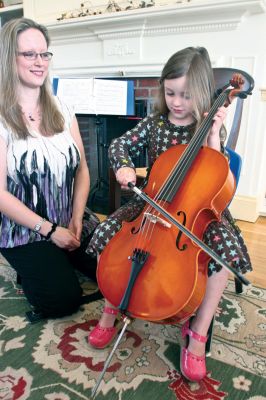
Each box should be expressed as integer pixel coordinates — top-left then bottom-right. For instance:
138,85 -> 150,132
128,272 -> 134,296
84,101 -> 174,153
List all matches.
88,47 -> 252,381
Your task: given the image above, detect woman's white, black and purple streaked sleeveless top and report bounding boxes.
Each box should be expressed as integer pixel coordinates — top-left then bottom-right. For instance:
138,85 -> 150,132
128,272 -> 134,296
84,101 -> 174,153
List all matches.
0,99 -> 80,248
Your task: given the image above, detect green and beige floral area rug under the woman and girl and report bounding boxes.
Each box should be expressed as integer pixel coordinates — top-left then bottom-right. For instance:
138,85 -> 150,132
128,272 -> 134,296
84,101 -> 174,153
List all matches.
0,258 -> 266,400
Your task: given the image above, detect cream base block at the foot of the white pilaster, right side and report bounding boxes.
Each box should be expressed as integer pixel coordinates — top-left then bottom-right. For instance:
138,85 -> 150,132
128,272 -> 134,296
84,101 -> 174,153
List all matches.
229,196 -> 260,222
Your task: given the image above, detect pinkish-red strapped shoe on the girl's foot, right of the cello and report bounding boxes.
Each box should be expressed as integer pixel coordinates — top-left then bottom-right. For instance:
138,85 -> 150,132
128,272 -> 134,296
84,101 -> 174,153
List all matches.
180,320 -> 208,382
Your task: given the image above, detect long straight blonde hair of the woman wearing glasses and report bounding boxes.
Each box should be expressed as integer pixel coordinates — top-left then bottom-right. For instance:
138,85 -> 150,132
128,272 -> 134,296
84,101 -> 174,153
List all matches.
0,18 -> 65,139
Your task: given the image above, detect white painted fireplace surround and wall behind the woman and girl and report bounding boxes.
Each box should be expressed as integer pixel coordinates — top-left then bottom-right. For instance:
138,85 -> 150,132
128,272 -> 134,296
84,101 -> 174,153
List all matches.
24,0 -> 266,221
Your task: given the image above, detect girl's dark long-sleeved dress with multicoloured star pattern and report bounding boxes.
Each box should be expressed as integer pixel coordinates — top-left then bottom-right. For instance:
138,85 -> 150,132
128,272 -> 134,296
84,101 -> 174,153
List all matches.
87,115 -> 252,276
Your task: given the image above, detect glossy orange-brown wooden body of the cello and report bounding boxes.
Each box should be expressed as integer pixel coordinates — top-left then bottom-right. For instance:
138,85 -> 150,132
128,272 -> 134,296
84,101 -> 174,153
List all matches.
97,145 -> 235,323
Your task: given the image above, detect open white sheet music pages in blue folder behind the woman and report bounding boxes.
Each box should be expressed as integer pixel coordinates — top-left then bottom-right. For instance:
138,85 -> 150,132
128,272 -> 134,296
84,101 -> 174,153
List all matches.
57,78 -> 128,115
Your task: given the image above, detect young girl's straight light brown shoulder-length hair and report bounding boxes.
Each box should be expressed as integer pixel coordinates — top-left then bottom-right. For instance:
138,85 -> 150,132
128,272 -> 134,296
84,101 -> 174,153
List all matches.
155,47 -> 218,134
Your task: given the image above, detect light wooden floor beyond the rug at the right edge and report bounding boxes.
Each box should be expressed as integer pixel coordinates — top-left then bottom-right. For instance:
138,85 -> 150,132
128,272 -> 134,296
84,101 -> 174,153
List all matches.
96,215 -> 266,288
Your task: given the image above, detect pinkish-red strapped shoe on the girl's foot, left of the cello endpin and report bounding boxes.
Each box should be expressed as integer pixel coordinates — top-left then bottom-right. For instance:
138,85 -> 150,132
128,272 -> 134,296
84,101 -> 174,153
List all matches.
88,307 -> 118,349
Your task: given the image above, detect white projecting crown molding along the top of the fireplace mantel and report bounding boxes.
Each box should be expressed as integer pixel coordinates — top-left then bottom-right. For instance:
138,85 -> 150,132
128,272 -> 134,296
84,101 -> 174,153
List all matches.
45,0 -> 266,44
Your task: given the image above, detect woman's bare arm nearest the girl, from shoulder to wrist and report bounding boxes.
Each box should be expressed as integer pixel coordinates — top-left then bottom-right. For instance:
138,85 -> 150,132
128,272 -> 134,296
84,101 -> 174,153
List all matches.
69,117 -> 90,240
